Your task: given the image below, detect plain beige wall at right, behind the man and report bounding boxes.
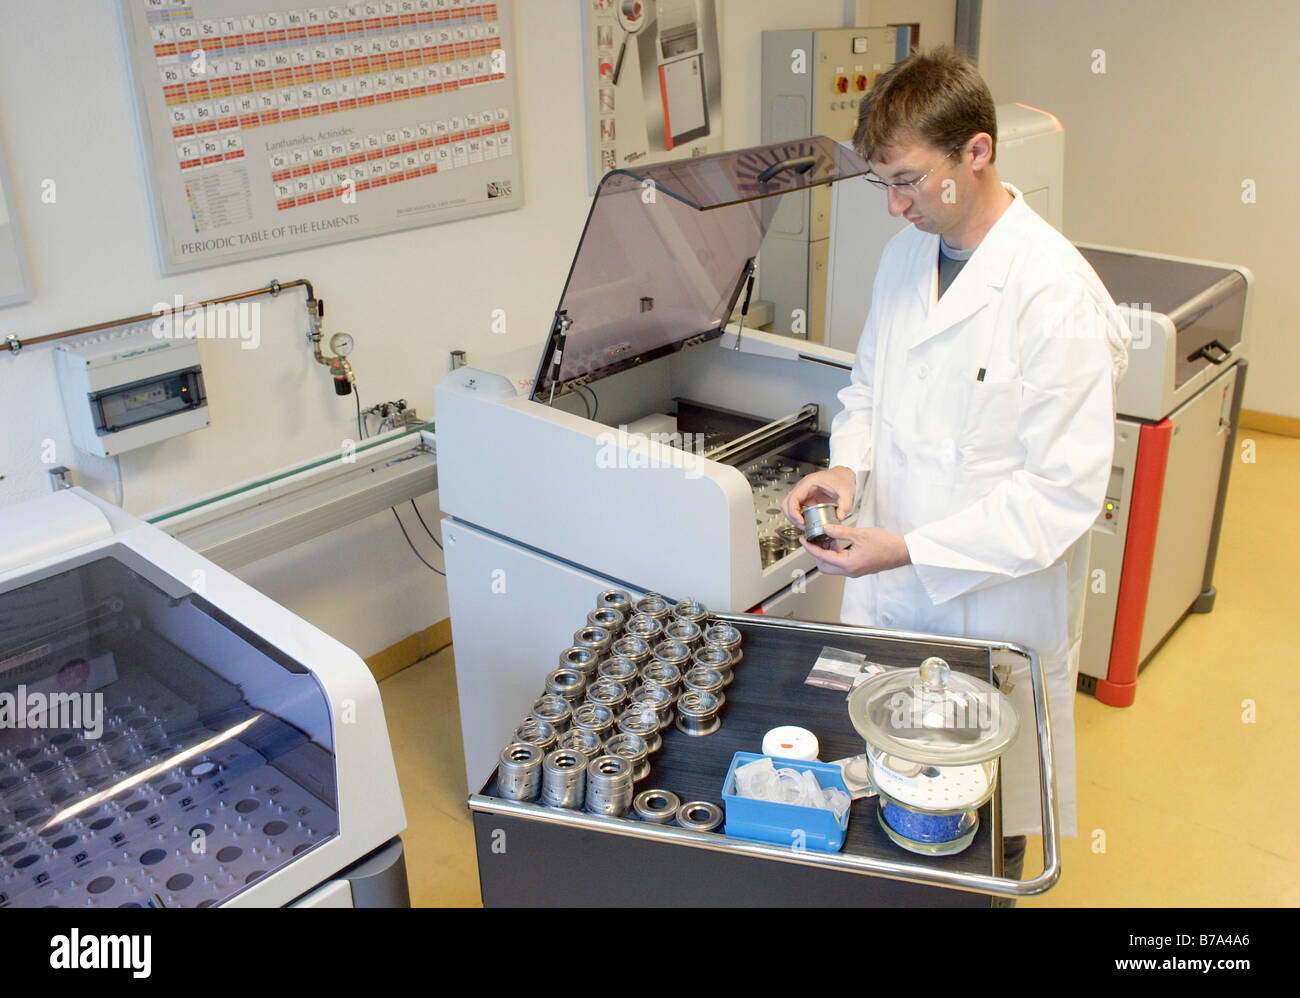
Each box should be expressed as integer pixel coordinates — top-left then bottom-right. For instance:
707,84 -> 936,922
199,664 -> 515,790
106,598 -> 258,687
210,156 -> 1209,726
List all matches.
980,0 -> 1300,417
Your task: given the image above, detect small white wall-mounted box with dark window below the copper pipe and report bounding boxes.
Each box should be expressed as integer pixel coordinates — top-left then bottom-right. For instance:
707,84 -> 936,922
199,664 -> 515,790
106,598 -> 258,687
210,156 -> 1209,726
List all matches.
55,325 -> 209,457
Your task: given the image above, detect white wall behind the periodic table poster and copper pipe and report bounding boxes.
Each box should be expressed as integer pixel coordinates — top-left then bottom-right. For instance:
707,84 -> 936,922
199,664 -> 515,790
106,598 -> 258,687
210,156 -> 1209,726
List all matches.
0,0 -> 845,655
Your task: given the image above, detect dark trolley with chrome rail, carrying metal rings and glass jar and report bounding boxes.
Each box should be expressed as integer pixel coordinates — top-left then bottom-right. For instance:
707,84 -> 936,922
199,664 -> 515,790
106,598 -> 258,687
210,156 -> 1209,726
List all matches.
469,615 -> 1058,907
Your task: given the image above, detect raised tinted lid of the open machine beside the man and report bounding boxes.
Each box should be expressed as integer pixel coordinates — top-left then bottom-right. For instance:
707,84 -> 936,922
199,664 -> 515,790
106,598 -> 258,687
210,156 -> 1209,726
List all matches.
533,135 -> 870,402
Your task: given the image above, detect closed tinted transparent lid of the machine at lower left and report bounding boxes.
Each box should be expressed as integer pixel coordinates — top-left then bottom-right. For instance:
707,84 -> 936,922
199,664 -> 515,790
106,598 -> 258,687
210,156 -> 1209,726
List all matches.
0,548 -> 339,908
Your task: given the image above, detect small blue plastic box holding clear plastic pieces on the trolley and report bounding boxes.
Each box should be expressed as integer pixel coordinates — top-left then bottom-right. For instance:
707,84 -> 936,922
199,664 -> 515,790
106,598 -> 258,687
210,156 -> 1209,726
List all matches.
723,752 -> 849,852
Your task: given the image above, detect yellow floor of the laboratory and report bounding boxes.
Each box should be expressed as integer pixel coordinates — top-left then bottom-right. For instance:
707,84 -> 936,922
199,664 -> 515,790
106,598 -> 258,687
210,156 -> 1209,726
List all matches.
380,431 -> 1300,907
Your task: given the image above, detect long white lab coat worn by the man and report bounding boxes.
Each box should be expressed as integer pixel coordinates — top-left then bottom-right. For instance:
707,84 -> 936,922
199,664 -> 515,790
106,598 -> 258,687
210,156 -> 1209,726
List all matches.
831,185 -> 1131,836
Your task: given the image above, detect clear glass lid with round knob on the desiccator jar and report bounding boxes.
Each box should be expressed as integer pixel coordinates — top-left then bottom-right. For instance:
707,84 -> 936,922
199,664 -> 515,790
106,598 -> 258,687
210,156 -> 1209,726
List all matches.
849,658 -> 1019,765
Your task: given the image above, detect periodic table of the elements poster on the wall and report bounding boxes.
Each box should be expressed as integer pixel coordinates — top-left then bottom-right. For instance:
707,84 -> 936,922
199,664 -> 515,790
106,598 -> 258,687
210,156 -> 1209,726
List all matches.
121,0 -> 523,274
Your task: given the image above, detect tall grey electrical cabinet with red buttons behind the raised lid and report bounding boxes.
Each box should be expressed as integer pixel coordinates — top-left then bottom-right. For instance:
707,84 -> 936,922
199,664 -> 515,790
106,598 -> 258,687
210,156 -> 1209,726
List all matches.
758,27 -> 911,343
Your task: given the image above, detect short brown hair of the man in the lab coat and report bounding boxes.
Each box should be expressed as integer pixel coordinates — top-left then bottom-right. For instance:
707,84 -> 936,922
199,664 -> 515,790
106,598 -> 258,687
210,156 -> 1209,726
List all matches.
853,45 -> 997,160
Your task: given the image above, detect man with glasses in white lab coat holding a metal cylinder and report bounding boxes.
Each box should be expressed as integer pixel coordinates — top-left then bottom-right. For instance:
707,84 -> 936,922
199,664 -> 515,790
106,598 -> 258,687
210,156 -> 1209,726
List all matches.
784,49 -> 1131,876
